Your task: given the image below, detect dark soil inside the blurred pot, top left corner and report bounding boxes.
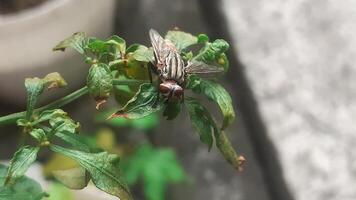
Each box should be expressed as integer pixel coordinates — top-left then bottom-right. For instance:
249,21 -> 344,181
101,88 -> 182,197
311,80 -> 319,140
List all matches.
0,0 -> 49,15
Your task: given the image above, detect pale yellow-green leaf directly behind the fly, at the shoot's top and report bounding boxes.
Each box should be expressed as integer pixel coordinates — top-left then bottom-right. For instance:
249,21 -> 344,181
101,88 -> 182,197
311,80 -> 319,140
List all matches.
166,31 -> 198,50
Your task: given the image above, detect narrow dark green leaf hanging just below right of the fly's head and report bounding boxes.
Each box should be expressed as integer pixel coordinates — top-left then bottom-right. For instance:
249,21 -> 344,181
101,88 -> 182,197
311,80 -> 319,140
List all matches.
184,98 -> 219,150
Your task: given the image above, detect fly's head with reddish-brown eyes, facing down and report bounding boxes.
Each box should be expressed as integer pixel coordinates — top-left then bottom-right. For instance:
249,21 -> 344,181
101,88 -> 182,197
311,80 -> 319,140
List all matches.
159,80 -> 184,101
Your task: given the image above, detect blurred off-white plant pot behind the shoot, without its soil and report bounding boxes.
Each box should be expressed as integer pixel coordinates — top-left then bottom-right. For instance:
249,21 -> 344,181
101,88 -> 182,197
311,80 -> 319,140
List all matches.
0,0 -> 115,106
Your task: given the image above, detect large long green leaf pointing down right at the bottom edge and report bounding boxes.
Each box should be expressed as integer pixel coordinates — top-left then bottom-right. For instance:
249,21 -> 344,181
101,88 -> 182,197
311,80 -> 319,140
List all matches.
50,145 -> 132,200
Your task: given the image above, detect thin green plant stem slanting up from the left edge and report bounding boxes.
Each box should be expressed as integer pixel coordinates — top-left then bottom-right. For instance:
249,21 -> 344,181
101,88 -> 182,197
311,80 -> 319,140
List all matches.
0,86 -> 88,126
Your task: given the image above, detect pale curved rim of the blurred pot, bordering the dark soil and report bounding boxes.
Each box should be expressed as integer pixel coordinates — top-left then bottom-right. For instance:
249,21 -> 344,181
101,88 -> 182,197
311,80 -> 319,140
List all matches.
0,0 -> 70,25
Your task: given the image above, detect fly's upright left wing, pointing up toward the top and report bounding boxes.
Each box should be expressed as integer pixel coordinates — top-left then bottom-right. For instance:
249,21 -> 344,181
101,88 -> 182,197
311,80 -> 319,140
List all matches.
149,29 -> 170,68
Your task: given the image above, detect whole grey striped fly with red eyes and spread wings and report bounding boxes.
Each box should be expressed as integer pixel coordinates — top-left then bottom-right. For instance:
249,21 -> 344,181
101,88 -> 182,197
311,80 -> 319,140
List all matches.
149,29 -> 223,101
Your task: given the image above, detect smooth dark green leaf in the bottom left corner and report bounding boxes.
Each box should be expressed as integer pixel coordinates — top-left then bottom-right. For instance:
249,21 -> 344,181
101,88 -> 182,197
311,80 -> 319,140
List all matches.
0,165 -> 47,200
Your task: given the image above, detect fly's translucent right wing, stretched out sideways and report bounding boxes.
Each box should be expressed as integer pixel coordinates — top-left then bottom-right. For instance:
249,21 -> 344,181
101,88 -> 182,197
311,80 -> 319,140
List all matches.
184,61 -> 224,74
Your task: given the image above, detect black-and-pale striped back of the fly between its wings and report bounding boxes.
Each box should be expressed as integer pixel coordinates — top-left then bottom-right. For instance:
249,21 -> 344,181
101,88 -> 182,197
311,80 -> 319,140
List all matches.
162,52 -> 184,83
